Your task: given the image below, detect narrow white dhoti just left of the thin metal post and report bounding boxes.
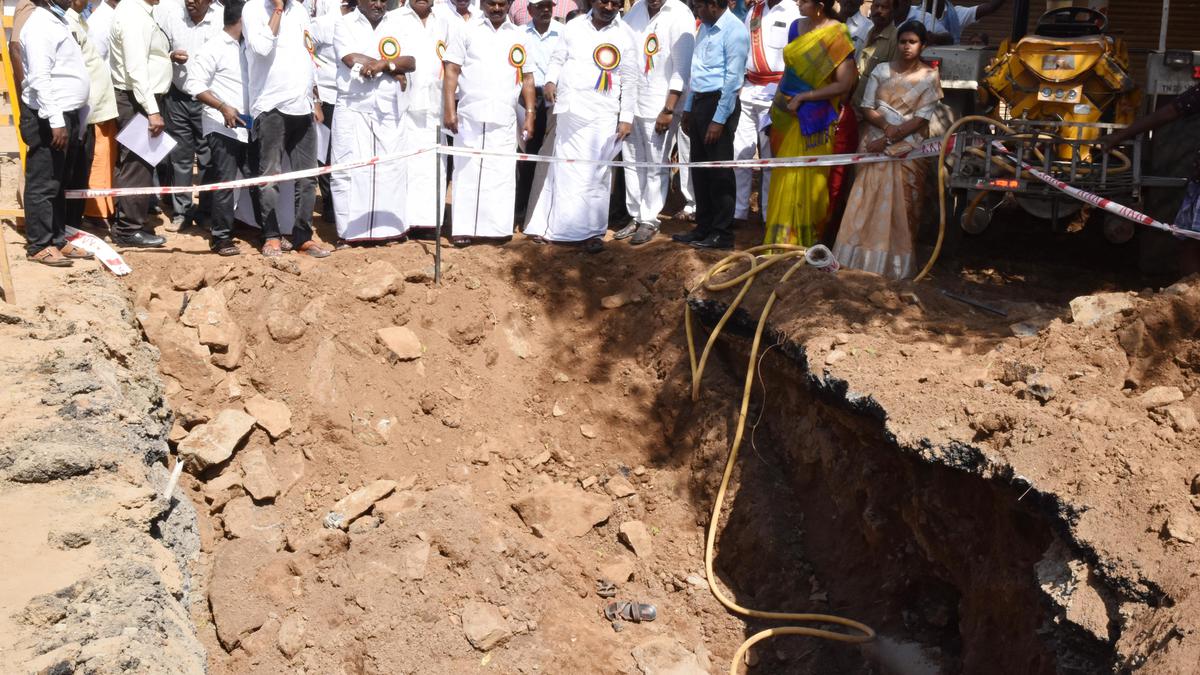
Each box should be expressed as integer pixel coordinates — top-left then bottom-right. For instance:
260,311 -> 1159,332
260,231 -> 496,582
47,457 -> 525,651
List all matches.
401,109 -> 448,229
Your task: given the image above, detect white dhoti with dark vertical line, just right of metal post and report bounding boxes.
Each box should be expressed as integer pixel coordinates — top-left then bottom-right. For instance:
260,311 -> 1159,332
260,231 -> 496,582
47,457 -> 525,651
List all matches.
450,112 -> 517,239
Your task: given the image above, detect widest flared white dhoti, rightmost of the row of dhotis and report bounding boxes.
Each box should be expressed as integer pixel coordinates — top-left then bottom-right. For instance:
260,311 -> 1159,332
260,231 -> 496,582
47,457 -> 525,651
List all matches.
526,113 -> 617,241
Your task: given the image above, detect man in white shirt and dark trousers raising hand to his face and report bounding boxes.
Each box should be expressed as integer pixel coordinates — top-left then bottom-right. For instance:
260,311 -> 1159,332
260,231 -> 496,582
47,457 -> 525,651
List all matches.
242,0 -> 329,258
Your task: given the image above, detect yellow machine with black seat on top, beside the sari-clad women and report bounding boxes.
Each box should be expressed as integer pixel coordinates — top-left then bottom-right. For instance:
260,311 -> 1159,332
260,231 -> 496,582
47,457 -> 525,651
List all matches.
983,7 -> 1141,162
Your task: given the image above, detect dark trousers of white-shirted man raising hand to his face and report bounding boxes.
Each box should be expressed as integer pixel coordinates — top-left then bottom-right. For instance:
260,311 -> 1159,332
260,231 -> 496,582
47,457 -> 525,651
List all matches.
253,110 -> 317,249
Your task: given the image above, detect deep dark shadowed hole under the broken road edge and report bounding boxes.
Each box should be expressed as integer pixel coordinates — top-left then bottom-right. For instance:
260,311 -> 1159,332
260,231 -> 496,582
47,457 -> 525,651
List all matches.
692,300 -> 1117,675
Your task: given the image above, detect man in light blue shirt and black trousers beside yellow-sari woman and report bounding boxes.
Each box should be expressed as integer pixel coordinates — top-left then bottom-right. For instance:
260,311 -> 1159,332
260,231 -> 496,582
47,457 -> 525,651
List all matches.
672,0 -> 750,249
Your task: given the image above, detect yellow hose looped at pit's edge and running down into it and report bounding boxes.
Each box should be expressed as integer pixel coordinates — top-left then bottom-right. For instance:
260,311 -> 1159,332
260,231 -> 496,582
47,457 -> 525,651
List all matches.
684,244 -> 875,675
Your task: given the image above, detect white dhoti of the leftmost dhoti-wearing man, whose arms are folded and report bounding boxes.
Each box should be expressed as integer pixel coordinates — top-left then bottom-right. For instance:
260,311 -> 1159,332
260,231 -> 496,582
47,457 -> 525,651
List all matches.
329,107 -> 408,241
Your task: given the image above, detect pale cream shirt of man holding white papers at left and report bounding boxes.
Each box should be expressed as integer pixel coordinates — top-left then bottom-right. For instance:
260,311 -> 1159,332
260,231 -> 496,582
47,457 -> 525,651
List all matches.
108,0 -> 172,115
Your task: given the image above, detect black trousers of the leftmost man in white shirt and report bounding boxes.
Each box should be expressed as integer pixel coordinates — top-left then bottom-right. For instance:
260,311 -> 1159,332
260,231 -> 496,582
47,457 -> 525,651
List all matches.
20,101 -> 88,256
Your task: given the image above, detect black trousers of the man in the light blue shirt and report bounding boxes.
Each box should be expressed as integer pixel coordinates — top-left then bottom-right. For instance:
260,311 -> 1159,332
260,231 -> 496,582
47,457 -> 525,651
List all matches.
686,91 -> 742,237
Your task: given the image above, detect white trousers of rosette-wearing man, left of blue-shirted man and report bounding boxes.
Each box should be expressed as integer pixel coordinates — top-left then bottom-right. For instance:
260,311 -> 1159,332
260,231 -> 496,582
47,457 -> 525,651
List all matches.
622,118 -> 679,225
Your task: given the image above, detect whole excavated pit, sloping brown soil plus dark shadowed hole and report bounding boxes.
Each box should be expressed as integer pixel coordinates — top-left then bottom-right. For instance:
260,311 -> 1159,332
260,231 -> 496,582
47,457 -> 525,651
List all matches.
110,239 -> 1132,674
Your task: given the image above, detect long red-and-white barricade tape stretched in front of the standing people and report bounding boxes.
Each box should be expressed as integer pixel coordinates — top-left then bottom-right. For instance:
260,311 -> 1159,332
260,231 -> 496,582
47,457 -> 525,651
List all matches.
65,138 -> 942,199
